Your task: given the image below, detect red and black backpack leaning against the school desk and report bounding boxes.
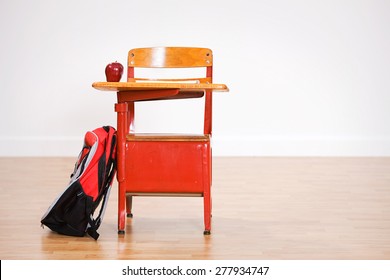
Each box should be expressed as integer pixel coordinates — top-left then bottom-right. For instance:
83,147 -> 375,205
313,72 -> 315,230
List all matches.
41,126 -> 116,240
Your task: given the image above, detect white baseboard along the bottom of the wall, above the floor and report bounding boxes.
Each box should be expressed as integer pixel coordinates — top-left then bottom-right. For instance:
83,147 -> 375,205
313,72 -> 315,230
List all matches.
0,136 -> 390,157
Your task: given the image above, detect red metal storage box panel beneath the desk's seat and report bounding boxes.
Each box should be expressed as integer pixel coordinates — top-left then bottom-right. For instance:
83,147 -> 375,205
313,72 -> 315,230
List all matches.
125,141 -> 211,194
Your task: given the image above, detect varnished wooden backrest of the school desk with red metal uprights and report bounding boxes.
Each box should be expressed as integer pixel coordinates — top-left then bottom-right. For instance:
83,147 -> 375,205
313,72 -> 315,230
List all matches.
127,47 -> 213,135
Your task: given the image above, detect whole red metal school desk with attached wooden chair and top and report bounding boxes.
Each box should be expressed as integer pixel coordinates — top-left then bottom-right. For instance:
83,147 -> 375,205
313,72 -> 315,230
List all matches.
93,47 -> 227,234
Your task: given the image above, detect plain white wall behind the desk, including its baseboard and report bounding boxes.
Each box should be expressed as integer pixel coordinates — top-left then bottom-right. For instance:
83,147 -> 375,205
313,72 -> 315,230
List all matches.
0,0 -> 390,156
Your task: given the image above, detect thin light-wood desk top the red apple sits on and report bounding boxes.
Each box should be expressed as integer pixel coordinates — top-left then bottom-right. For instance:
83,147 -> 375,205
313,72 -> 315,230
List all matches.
92,81 -> 229,92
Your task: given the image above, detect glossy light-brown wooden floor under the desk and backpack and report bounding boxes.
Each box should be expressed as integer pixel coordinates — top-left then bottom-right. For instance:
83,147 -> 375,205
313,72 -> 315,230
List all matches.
0,157 -> 390,260
